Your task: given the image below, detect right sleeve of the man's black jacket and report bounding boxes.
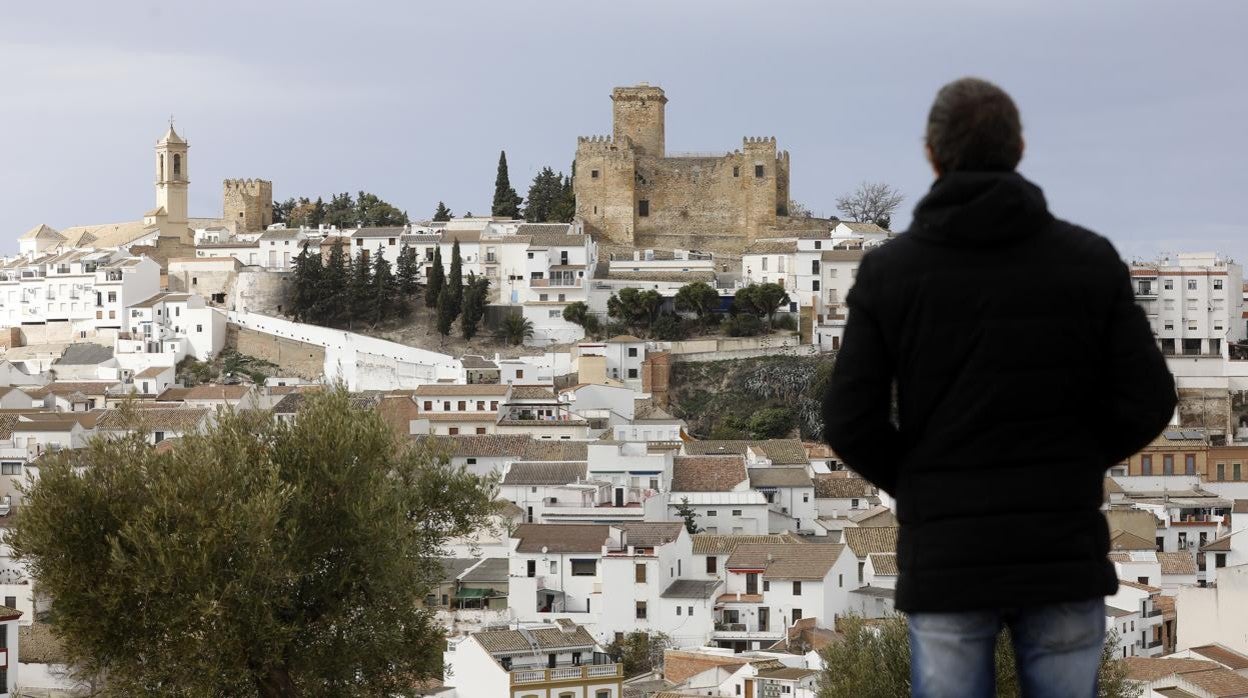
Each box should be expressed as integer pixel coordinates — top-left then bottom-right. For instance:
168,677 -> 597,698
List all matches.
1099,243 -> 1178,468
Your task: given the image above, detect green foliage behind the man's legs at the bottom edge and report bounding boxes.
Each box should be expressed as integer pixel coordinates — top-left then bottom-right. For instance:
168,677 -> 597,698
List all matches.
818,616 -> 1142,698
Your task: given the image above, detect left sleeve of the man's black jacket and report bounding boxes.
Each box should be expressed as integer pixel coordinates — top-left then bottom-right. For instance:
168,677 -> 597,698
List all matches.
824,255 -> 902,494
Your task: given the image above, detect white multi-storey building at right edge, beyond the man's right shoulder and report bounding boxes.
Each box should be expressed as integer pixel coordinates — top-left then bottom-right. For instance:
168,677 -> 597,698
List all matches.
1131,252 -> 1246,358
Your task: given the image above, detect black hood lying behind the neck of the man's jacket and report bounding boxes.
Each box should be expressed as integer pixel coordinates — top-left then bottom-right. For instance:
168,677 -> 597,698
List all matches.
910,172 -> 1053,247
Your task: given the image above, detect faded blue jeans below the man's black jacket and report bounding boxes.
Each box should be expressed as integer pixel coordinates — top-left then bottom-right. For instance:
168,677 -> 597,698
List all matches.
910,598 -> 1106,698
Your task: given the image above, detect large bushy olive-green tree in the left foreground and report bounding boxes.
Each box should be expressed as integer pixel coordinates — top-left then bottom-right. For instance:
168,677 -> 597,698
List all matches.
6,390 -> 494,698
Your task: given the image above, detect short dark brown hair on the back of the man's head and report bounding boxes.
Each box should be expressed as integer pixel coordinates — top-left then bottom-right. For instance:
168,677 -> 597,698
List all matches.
927,77 -> 1022,172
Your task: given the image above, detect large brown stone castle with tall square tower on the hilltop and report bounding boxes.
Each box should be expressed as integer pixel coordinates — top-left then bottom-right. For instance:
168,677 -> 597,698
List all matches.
573,84 -> 810,252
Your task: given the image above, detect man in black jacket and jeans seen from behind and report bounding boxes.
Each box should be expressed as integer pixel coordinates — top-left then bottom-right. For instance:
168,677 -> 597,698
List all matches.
824,79 -> 1176,698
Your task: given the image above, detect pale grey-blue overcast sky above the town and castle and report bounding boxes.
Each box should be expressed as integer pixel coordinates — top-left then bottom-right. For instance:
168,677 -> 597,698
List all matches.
0,0 -> 1248,260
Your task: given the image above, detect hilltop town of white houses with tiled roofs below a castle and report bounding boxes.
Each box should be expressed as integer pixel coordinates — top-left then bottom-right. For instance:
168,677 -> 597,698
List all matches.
0,85 -> 1248,698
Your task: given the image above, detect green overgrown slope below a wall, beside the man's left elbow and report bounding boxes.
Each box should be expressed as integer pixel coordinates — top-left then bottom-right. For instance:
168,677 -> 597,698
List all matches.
669,355 -> 834,441
